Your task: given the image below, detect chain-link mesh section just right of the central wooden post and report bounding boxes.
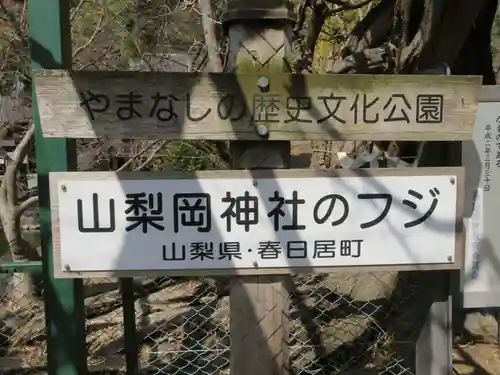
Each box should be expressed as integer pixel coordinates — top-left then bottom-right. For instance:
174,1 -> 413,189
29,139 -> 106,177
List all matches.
289,272 -> 421,375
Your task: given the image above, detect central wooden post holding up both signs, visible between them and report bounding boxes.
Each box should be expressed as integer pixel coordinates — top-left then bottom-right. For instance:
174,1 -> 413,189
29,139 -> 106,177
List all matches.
225,0 -> 292,375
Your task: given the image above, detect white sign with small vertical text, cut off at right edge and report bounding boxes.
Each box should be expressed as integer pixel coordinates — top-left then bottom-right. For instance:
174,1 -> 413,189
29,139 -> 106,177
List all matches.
462,102 -> 500,308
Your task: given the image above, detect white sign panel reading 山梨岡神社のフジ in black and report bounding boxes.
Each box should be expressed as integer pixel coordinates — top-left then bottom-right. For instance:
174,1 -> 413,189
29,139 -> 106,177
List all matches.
51,172 -> 457,272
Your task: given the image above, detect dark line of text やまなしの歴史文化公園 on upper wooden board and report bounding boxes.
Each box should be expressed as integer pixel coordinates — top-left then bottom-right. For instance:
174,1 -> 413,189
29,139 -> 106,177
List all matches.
80,90 -> 444,124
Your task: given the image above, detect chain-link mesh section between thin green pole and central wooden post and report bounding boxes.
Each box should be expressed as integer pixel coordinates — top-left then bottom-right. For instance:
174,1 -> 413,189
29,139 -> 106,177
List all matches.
132,278 -> 230,375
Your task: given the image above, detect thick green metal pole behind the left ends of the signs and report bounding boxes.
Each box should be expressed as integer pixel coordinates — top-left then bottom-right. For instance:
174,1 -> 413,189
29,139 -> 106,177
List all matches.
28,0 -> 87,375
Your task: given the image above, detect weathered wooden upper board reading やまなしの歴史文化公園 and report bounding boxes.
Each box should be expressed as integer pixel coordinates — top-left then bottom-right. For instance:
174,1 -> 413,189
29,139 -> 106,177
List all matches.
34,70 -> 481,141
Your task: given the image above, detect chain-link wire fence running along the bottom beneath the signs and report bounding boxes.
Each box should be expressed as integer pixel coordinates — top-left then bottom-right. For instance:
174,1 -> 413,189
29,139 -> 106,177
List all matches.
0,269 -> 434,375
